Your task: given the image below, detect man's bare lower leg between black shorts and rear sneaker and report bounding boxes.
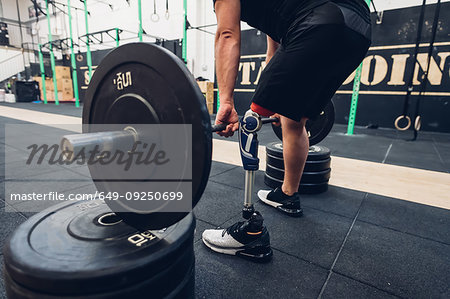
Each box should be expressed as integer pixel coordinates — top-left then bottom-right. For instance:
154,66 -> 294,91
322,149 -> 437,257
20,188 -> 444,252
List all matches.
281,116 -> 309,196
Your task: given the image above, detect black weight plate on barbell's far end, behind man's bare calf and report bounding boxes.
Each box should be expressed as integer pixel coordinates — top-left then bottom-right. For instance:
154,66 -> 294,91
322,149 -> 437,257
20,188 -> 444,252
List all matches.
272,101 -> 335,146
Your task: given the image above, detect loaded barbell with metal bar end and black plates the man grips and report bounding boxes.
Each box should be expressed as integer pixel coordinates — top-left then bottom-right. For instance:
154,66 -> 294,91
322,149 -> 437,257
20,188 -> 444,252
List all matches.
61,43 -> 334,229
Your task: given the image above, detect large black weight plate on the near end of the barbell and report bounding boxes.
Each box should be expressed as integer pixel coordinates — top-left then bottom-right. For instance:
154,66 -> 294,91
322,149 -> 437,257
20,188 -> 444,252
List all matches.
83,43 -> 212,229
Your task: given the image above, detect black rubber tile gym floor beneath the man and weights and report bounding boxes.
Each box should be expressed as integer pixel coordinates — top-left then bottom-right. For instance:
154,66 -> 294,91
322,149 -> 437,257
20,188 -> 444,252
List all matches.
0,103 -> 450,298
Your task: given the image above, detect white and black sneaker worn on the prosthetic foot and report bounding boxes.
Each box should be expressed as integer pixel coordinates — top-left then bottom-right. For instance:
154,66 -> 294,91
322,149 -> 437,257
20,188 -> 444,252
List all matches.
202,212 -> 273,262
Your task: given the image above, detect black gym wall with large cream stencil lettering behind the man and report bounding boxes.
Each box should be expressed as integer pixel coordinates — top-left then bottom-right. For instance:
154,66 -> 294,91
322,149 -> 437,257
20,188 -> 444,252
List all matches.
230,2 -> 450,132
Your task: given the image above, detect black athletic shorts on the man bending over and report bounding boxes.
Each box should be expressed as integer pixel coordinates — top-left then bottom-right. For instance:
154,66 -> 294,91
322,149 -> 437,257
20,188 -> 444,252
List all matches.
253,2 -> 371,121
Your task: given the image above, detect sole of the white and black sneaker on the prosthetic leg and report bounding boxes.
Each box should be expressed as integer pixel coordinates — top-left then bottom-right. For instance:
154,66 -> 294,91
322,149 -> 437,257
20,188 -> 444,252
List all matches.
202,238 -> 273,263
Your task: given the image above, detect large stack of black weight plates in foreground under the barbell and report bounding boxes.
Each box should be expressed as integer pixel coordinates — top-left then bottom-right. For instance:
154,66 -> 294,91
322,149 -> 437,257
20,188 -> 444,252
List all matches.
4,201 -> 195,299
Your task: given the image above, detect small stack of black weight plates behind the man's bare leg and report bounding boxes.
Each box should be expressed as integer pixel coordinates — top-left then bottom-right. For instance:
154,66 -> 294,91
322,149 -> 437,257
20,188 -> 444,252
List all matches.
264,141 -> 331,194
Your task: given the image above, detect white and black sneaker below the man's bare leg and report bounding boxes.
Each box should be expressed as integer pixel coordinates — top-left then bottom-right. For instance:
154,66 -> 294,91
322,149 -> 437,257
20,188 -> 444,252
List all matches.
258,187 -> 303,217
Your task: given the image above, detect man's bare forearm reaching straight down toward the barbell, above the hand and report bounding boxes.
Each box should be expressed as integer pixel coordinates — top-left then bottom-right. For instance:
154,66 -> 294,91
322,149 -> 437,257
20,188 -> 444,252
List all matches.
215,31 -> 241,104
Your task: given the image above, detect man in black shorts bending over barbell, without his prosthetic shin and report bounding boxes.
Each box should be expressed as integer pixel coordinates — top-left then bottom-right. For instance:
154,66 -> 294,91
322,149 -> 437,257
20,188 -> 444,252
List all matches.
203,0 -> 371,258
